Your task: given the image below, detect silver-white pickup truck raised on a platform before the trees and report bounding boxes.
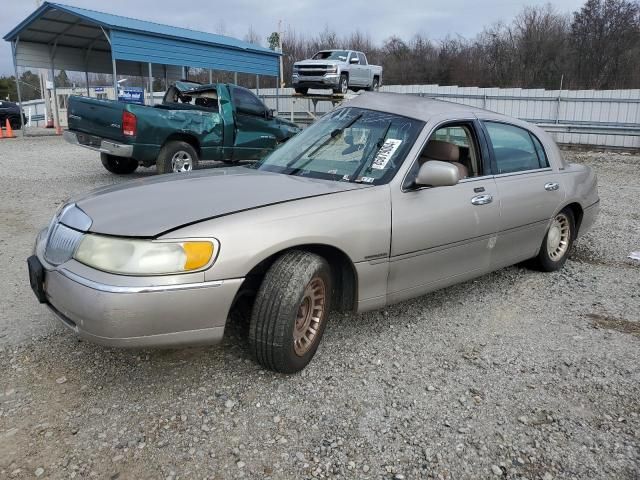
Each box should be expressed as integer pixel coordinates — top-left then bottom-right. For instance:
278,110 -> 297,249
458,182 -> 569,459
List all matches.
291,50 -> 382,95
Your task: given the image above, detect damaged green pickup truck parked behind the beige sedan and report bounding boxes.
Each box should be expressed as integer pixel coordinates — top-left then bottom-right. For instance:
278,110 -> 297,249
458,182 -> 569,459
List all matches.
64,81 -> 300,174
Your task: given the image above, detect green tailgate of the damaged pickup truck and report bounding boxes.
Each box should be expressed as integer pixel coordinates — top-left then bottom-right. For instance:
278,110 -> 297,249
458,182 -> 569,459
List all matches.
67,95 -> 125,140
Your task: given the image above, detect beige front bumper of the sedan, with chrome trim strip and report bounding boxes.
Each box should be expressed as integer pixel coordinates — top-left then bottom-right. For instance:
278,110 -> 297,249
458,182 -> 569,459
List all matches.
28,249 -> 243,347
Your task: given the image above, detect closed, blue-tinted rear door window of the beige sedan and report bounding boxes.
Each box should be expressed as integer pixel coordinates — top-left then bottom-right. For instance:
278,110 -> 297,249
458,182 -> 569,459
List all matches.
484,122 -> 541,174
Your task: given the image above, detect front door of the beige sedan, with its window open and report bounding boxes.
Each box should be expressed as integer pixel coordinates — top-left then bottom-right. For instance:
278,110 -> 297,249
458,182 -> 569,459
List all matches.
388,121 -> 500,303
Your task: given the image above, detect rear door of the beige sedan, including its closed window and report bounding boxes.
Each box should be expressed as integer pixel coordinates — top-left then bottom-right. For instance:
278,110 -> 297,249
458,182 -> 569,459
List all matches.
483,121 -> 565,268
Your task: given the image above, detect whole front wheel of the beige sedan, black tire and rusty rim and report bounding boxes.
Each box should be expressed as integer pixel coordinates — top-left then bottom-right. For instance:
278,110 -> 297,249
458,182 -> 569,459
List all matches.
249,250 -> 332,373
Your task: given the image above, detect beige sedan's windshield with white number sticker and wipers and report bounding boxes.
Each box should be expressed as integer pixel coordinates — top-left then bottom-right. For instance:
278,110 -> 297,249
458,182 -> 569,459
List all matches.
252,107 -> 424,185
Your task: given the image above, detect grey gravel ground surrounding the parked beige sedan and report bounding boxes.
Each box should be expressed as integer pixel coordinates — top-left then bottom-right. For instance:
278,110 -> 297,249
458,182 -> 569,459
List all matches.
0,137 -> 640,480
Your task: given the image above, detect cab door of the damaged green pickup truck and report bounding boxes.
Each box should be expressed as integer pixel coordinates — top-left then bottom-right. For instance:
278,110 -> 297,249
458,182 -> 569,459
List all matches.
231,86 -> 277,160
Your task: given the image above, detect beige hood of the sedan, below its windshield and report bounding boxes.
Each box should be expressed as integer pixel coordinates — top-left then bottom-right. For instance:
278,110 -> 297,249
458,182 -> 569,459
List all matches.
70,167 -> 370,238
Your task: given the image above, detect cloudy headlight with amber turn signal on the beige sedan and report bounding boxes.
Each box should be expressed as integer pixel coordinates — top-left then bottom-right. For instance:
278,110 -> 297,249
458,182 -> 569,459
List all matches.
73,234 -> 217,275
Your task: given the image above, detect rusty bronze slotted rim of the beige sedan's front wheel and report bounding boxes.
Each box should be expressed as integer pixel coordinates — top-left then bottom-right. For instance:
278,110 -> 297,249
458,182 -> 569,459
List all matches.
293,277 -> 326,357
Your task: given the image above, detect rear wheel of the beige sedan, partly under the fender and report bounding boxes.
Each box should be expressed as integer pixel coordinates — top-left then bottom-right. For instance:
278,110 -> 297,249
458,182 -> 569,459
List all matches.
531,208 -> 576,272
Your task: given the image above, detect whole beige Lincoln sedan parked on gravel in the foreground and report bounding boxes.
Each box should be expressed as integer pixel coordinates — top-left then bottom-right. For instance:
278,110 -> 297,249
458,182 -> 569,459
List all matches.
28,93 -> 599,372
